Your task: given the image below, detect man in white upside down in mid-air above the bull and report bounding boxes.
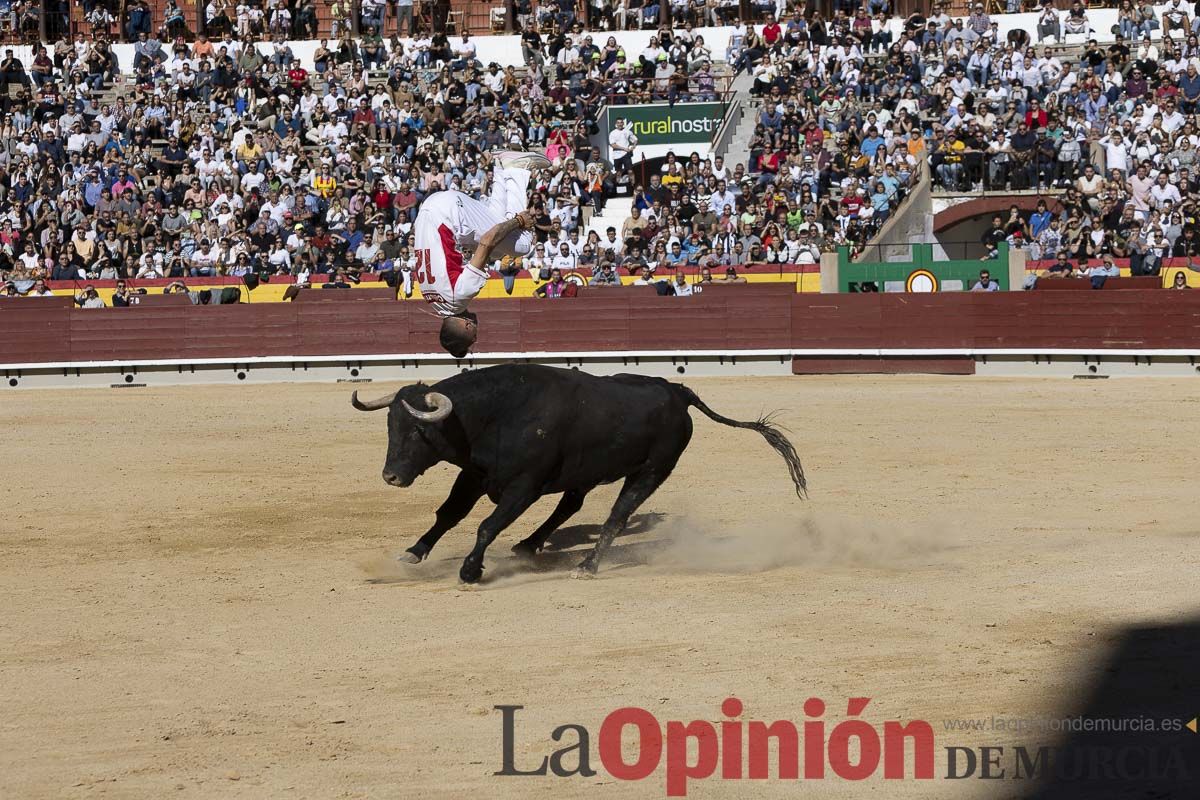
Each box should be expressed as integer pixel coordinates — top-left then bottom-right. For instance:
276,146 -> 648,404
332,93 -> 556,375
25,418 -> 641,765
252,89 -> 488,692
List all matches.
413,151 -> 550,359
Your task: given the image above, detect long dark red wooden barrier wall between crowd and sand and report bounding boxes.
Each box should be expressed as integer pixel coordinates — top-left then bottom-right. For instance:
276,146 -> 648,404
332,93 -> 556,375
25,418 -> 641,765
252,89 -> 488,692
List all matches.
7,284 -> 1200,363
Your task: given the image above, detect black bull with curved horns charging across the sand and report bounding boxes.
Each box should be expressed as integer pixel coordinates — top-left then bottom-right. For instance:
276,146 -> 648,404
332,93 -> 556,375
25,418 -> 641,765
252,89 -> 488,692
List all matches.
350,365 -> 806,583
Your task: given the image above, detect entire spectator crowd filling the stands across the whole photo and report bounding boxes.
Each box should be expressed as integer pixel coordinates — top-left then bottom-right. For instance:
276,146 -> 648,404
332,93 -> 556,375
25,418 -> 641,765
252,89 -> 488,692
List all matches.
0,0 -> 1200,302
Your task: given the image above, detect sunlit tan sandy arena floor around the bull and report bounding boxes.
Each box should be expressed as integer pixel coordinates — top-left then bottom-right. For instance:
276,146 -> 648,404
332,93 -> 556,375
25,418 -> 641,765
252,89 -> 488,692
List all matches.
0,378 -> 1200,799
